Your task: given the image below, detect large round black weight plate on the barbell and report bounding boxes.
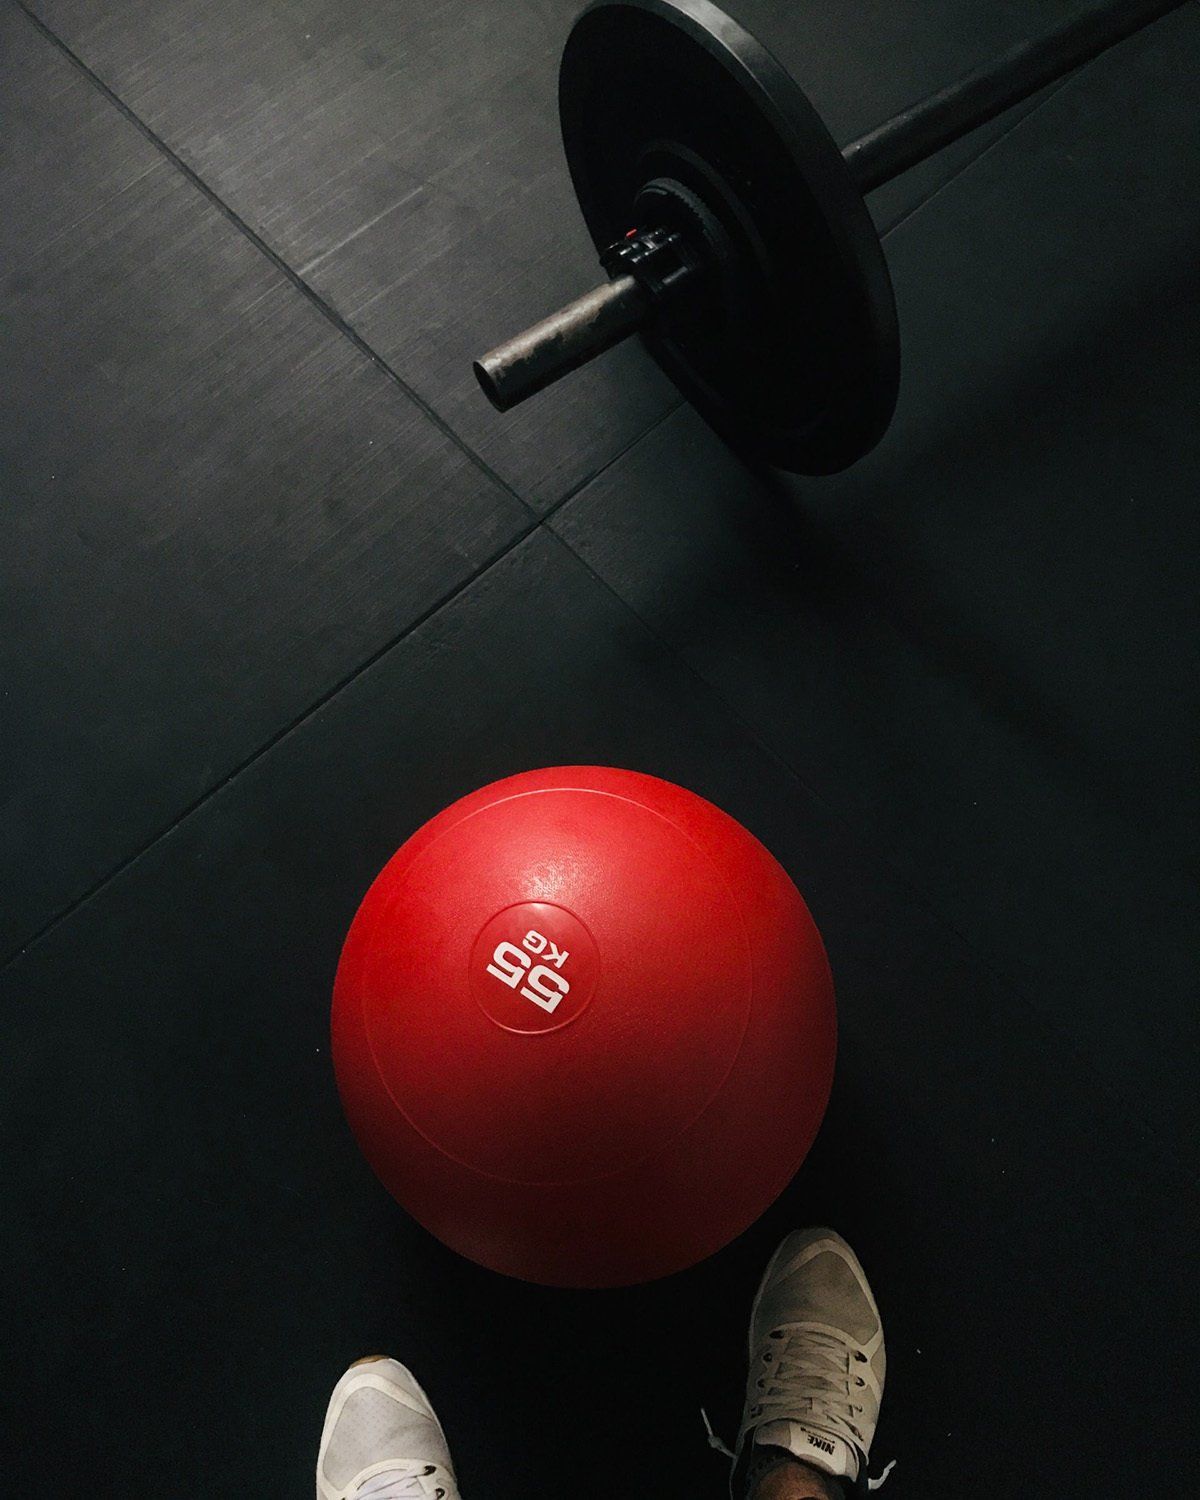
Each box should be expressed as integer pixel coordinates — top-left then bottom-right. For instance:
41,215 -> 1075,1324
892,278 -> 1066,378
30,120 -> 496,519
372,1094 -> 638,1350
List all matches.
558,0 -> 900,474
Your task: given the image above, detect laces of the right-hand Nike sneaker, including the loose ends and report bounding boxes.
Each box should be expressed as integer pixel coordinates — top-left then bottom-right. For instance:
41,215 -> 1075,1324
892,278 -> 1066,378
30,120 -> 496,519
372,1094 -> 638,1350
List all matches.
701,1323 -> 896,1490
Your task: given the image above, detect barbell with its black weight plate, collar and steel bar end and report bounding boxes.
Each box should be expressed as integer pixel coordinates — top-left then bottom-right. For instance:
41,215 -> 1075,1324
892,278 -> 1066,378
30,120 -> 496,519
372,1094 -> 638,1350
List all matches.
474,0 -> 1185,474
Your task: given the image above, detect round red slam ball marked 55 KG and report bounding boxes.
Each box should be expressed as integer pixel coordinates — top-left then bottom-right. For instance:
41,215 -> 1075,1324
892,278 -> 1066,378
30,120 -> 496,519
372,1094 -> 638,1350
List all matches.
333,767 -> 836,1287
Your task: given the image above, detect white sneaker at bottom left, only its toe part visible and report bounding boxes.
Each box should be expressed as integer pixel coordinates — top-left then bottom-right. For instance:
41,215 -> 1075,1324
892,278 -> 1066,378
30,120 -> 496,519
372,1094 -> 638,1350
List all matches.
317,1355 -> 459,1500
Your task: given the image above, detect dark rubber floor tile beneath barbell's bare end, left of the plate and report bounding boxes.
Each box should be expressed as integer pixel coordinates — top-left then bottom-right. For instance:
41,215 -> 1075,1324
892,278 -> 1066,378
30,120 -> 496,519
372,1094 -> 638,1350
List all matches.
18,0 -> 678,507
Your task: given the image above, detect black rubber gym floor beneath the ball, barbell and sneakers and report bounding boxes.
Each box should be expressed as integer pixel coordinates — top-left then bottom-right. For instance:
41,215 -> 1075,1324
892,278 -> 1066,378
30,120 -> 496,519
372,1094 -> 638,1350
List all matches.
0,0 -> 1200,1500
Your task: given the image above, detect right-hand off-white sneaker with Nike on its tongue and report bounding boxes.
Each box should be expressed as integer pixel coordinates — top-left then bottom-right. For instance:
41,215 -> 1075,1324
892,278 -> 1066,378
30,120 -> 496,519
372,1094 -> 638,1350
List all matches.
734,1229 -> 891,1493
